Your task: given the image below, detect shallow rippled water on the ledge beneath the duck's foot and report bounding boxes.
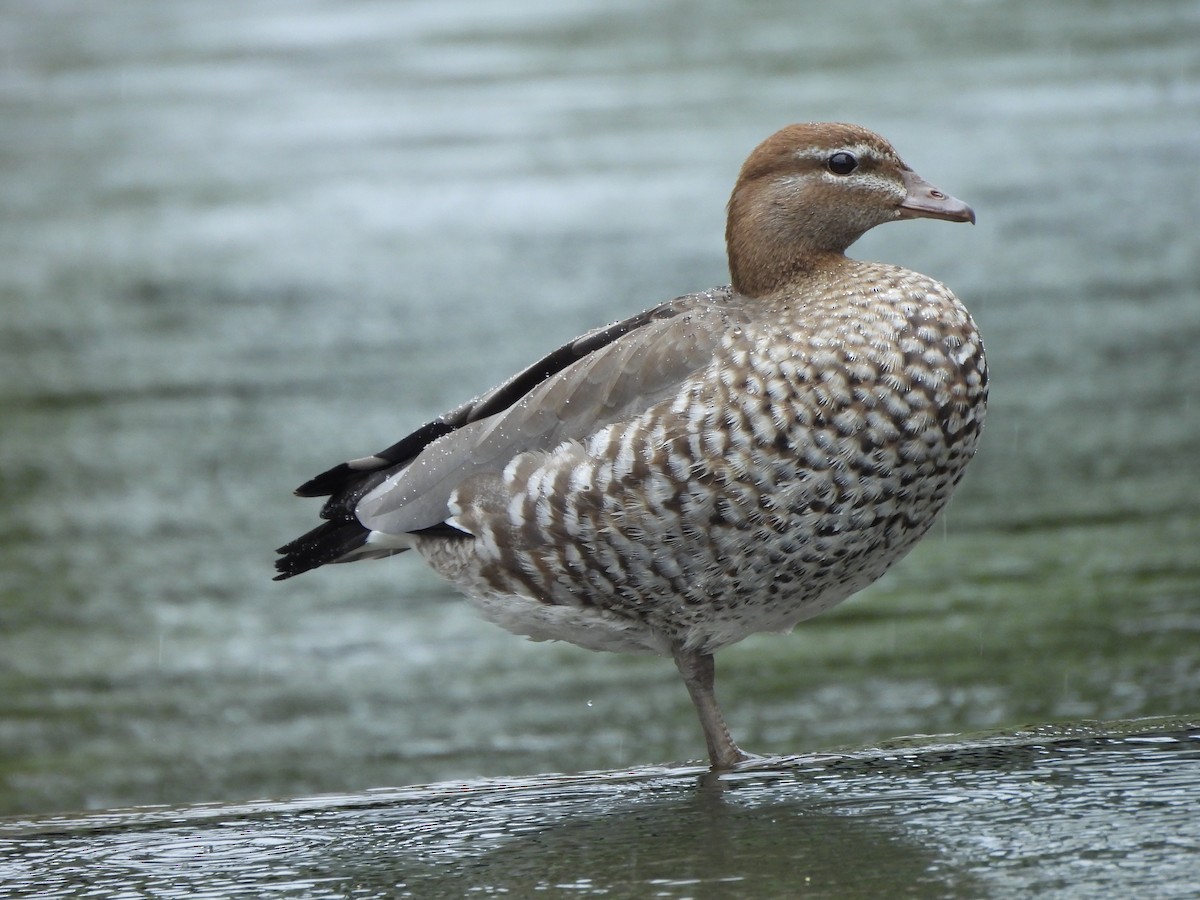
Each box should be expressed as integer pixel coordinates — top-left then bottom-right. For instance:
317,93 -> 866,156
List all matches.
0,720 -> 1200,899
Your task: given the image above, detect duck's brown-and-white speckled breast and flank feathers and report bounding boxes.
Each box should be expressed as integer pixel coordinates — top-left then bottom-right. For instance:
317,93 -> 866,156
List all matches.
439,264 -> 986,652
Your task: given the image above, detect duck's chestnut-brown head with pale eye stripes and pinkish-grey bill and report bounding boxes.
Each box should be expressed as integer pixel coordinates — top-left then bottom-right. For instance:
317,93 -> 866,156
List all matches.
725,122 -> 974,296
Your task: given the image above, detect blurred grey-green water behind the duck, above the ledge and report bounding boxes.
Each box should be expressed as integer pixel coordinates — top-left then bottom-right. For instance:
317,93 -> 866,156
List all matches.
0,0 -> 1200,815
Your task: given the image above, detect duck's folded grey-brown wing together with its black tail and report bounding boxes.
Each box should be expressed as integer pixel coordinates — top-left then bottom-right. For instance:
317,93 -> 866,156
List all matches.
276,287 -> 743,580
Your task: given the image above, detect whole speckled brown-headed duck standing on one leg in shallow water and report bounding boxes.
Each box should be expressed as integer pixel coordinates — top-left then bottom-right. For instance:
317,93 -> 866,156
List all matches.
275,122 -> 988,772
